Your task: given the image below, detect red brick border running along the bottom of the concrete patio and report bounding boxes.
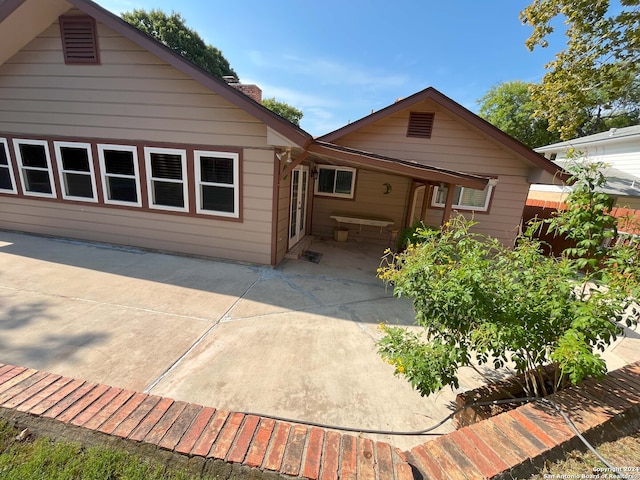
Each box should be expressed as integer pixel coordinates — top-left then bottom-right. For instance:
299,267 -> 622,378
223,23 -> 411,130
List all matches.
0,362 -> 640,480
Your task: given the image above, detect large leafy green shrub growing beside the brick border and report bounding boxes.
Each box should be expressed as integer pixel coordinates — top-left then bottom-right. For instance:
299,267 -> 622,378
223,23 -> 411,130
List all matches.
378,161 -> 640,395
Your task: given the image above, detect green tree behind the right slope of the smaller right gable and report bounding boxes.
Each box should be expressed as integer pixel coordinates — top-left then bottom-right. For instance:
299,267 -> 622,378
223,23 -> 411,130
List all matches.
477,81 -> 560,148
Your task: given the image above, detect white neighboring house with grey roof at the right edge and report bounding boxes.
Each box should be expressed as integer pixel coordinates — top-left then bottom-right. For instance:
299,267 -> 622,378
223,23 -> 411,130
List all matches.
528,125 -> 640,210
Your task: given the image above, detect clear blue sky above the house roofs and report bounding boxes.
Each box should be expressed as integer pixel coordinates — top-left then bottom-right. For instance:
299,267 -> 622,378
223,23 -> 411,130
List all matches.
97,0 -> 564,135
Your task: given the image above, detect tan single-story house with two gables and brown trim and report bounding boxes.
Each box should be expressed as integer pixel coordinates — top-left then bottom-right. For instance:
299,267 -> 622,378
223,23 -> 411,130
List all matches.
0,0 -> 556,265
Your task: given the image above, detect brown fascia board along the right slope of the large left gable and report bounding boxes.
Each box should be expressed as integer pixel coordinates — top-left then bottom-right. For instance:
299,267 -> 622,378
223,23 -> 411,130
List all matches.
63,0 -> 312,146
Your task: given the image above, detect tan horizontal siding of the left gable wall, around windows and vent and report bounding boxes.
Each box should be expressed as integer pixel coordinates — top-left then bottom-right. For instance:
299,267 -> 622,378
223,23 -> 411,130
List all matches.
0,14 -> 273,264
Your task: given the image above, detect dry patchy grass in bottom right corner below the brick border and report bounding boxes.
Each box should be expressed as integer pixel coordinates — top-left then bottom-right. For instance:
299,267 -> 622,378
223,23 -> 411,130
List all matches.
531,431 -> 640,480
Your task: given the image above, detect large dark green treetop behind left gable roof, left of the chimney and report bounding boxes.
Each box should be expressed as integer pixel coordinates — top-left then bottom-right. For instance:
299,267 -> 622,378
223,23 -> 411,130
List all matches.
122,10 -> 237,78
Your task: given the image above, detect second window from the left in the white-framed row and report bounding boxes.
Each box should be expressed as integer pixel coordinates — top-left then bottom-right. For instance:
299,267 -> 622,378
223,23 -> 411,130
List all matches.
13,139 -> 56,198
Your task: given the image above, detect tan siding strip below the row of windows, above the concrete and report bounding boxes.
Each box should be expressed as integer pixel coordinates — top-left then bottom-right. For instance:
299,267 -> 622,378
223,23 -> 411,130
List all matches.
0,197 -> 270,264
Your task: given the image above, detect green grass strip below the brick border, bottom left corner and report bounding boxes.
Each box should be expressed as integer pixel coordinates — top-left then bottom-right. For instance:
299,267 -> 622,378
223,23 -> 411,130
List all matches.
0,419 -> 207,480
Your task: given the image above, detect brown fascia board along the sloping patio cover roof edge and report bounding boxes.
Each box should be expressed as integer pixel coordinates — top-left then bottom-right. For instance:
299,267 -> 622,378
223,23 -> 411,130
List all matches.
308,143 -> 489,189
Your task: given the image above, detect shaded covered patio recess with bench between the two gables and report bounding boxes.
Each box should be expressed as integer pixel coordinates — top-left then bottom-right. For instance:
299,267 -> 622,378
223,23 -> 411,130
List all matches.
280,141 -> 495,258
